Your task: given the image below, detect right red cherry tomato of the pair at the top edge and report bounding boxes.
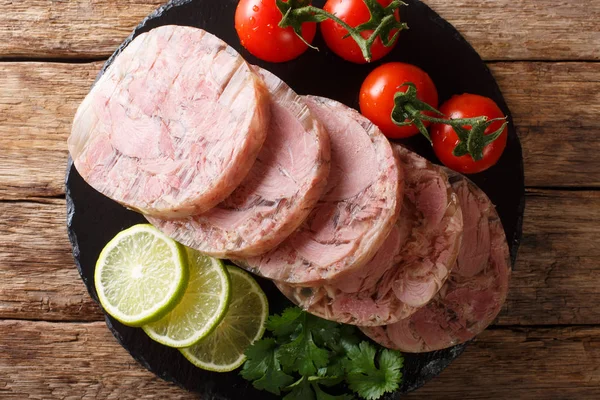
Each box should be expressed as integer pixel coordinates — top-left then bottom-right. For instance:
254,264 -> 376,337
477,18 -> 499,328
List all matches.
321,0 -> 400,64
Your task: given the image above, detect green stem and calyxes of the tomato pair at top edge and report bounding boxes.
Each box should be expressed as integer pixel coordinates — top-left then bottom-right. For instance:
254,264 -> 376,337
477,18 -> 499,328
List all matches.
276,0 -> 408,62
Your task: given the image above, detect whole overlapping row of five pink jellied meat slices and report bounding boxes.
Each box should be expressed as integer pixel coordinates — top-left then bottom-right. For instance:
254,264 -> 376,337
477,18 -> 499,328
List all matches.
69,26 -> 510,352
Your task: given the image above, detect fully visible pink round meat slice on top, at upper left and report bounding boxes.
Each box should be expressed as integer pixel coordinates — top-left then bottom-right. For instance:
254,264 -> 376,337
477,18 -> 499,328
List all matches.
68,26 -> 269,218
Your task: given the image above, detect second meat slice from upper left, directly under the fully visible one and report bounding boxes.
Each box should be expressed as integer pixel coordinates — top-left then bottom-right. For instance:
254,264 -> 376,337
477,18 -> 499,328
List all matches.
147,69 -> 330,258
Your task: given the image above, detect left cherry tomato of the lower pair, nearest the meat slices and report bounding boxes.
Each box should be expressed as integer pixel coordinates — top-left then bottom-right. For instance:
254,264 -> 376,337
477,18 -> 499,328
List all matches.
359,62 -> 438,139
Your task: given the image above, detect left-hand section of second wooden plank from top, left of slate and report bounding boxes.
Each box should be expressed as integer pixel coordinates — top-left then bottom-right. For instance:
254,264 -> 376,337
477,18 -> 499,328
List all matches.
0,63 -> 101,199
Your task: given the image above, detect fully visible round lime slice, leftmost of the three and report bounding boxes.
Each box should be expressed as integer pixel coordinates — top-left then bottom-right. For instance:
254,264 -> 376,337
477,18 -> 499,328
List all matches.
94,224 -> 188,326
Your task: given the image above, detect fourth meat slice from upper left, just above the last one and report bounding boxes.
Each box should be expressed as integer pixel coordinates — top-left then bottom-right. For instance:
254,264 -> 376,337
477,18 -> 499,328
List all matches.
277,145 -> 463,326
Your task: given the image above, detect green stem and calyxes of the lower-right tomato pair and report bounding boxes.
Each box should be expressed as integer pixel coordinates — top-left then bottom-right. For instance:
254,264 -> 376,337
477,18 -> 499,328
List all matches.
391,82 -> 508,161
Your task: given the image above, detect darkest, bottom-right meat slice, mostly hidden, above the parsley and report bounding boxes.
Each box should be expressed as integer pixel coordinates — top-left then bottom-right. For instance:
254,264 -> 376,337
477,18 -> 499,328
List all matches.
363,173 -> 510,353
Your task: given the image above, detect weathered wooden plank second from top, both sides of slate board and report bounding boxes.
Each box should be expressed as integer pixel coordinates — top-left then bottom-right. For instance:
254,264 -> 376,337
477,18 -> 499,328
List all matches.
0,63 -> 600,199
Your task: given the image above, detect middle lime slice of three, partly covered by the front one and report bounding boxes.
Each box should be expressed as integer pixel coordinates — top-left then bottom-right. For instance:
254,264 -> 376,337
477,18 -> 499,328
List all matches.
142,249 -> 230,347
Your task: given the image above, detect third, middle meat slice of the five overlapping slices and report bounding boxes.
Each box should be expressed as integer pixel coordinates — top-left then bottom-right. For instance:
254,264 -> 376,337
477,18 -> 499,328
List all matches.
240,97 -> 402,286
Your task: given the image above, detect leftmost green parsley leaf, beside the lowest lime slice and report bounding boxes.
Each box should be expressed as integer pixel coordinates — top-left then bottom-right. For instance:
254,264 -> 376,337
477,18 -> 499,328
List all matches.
241,339 -> 294,395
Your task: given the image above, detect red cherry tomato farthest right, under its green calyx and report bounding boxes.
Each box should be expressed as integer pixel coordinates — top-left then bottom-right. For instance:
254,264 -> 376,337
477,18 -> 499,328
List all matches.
431,94 -> 508,174
